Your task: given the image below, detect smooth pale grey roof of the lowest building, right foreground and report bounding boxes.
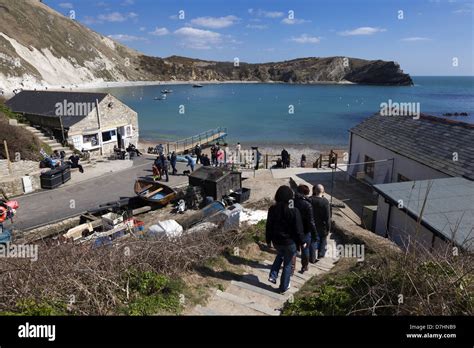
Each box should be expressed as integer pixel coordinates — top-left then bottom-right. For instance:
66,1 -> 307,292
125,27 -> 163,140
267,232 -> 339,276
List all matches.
374,178 -> 474,251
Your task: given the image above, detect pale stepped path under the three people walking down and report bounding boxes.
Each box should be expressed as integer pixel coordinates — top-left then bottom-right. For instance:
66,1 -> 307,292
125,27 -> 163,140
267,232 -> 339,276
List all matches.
189,236 -> 337,316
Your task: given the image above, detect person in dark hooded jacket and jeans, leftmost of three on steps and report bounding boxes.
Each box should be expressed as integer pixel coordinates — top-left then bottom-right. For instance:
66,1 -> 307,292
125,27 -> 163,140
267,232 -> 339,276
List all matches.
265,185 -> 306,293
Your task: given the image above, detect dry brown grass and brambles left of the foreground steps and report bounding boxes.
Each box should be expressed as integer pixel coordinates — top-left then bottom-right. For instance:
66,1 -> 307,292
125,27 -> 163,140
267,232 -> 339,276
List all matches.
0,231 -> 236,315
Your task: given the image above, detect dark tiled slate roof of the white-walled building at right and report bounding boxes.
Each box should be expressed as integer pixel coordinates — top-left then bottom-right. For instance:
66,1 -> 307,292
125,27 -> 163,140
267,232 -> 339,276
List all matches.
350,114 -> 474,180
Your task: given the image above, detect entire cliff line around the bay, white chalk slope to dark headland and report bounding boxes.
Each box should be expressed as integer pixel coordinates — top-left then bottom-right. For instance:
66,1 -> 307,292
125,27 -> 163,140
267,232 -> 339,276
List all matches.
0,0 -> 412,91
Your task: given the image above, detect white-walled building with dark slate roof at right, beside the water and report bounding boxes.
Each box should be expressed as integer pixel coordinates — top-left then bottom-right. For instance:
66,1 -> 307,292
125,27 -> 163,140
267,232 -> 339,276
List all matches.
348,115 -> 474,184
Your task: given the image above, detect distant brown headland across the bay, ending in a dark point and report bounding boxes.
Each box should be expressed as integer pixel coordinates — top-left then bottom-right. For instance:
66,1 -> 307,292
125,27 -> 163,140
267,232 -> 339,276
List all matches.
140,56 -> 413,85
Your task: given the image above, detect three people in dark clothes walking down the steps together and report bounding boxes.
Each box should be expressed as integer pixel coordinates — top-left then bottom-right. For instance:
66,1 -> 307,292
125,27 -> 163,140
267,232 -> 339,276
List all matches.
266,185 -> 331,293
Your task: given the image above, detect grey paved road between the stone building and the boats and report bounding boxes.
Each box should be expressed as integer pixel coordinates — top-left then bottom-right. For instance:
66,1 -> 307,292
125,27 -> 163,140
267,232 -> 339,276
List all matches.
9,156 -> 188,230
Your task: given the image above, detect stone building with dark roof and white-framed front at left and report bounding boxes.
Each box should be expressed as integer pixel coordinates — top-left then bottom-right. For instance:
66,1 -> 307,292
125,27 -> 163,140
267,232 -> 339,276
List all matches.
6,91 -> 139,157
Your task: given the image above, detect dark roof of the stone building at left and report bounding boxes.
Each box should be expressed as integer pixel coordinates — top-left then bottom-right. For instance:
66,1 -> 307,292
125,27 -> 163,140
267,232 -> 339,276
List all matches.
6,91 -> 107,127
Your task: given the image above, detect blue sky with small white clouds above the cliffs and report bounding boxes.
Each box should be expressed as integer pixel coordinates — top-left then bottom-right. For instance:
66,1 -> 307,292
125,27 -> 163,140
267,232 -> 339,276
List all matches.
44,0 -> 474,75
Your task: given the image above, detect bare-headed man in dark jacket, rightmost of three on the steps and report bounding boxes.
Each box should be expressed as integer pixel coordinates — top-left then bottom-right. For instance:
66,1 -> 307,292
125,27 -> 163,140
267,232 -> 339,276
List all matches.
310,185 -> 331,263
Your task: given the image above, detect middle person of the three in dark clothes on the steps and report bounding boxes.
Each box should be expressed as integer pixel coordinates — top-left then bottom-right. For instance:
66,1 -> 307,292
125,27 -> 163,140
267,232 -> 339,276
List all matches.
295,185 -> 316,273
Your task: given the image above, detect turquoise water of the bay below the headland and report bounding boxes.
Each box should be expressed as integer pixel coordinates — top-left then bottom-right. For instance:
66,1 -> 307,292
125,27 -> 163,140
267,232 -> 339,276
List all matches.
88,77 -> 474,145
